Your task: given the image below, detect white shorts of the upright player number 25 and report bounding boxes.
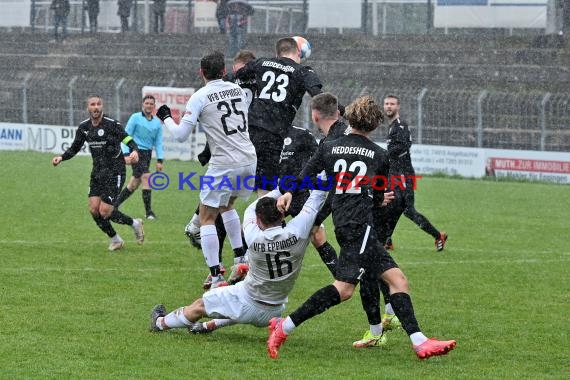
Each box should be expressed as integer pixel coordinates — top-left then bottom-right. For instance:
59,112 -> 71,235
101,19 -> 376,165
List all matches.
200,163 -> 257,208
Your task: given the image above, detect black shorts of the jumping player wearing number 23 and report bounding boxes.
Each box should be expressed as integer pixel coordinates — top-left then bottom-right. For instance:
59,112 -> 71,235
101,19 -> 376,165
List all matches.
249,127 -> 283,191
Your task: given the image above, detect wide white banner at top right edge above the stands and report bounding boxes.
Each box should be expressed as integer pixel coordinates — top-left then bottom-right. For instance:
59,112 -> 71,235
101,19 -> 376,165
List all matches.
434,0 -> 548,28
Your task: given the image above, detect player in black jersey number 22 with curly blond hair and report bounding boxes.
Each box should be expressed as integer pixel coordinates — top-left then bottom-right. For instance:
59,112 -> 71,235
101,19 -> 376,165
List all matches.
267,96 -> 456,359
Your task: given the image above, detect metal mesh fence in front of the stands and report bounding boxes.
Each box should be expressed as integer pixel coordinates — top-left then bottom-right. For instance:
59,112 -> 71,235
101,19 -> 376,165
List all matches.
0,72 -> 570,151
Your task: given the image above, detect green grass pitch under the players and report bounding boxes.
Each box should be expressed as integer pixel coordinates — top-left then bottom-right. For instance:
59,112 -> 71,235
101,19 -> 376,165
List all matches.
0,152 -> 570,379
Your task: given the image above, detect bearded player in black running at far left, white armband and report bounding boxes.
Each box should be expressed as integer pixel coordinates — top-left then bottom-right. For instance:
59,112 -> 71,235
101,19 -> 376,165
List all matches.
52,95 -> 144,251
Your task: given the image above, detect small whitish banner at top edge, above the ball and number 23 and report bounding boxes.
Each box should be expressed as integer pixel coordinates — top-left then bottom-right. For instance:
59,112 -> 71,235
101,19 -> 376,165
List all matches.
308,0 -> 362,29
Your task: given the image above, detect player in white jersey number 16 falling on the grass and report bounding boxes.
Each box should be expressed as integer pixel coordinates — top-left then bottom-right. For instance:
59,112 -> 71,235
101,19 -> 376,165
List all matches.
150,189 -> 326,333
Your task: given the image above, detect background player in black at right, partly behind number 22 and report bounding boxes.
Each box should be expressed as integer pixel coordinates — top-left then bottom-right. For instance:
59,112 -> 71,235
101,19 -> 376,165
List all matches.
377,95 -> 447,251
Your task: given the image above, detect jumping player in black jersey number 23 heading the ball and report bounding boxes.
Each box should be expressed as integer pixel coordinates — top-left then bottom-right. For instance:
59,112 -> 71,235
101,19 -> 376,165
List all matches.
236,37 -> 323,196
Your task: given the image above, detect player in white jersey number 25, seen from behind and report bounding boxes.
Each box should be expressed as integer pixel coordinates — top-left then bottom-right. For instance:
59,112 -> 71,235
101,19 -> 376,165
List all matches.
156,52 -> 257,288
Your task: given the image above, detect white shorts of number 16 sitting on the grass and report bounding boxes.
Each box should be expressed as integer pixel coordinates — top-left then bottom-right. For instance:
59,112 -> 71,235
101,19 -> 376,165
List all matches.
202,281 -> 285,327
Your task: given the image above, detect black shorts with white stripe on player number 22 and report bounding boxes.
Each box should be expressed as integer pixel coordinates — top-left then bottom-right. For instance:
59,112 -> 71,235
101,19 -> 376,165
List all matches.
335,224 -> 398,285
